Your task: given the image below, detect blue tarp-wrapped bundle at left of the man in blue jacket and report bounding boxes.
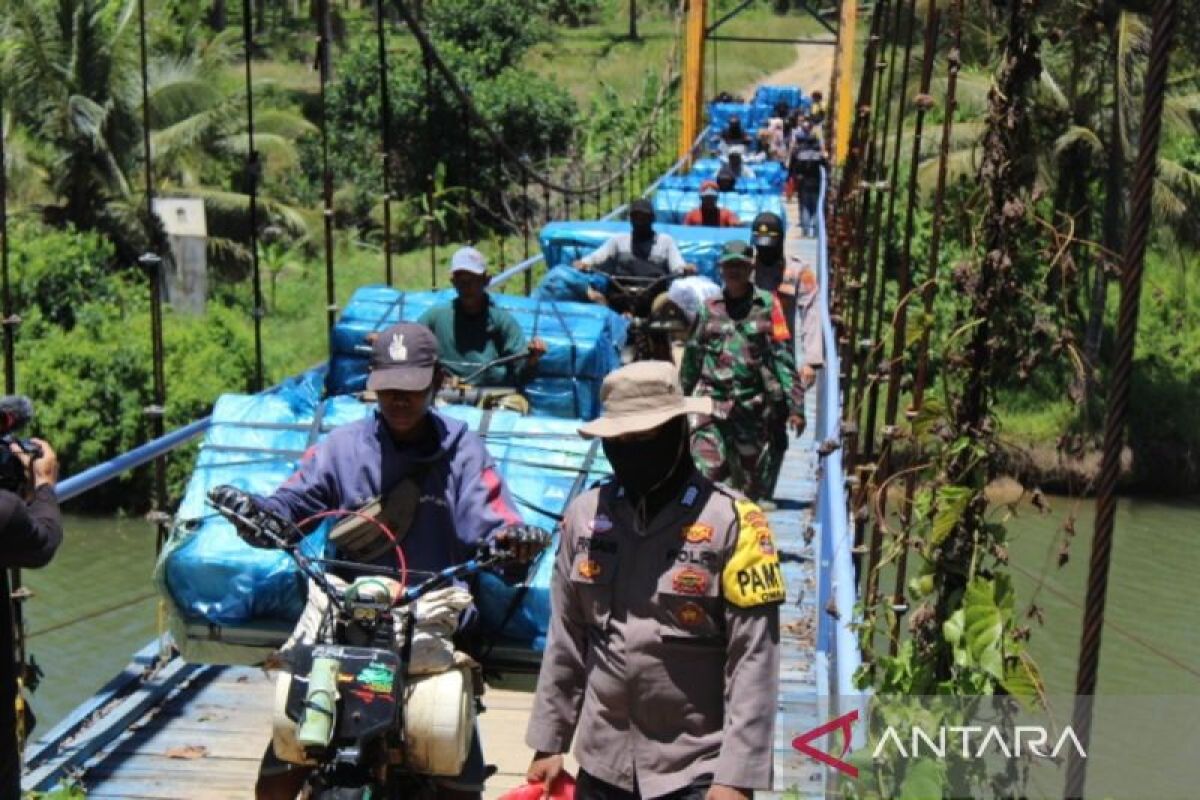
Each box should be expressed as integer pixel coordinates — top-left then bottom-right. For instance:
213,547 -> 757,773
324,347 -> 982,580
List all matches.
155,372 -> 371,663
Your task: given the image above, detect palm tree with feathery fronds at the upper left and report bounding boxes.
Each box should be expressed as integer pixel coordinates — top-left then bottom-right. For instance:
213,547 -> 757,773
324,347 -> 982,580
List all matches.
0,0 -> 313,259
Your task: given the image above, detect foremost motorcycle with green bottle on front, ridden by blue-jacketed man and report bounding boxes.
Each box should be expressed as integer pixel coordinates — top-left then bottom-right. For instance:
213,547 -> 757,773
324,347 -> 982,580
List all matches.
209,492 -> 550,800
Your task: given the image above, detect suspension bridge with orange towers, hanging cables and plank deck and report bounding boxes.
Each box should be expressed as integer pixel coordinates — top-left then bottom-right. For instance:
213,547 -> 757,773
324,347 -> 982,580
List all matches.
0,0 -> 1175,798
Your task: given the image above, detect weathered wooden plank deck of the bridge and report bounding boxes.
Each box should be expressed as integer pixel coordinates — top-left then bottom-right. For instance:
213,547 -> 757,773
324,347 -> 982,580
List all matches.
25,196 -> 828,800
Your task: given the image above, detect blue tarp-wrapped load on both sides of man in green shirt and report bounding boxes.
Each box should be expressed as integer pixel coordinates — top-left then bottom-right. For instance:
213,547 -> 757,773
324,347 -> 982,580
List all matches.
328,287 -> 628,420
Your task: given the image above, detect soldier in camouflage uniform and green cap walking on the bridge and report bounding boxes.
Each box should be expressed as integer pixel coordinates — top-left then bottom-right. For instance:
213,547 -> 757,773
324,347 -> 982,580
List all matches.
680,241 -> 804,500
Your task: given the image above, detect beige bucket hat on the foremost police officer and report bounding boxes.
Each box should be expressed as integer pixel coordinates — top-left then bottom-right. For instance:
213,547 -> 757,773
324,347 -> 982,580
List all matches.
580,361 -> 713,439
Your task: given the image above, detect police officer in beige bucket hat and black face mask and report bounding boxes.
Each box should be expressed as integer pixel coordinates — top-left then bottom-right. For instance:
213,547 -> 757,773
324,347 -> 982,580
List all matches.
526,361 -> 784,800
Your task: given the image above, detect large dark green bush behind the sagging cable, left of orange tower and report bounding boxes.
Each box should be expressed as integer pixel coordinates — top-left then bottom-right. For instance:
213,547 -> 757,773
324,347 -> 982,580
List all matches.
312,0 -> 577,239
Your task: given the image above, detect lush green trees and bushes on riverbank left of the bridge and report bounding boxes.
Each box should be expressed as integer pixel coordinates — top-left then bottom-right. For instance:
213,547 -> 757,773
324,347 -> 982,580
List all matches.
0,0 -> 811,509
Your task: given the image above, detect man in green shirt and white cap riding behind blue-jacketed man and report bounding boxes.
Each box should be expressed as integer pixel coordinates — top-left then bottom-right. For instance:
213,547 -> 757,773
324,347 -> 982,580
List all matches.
418,247 -> 546,386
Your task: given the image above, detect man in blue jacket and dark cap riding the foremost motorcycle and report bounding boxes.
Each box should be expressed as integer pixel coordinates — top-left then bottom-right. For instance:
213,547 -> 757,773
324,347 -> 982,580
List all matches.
220,323 -> 536,800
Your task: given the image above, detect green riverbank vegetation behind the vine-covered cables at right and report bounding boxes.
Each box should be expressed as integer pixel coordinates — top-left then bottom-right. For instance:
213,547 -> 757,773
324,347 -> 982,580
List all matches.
881,2 -> 1200,494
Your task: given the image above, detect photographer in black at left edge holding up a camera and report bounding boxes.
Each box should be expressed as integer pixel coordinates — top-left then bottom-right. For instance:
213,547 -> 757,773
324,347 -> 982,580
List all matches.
0,439 -> 62,798
